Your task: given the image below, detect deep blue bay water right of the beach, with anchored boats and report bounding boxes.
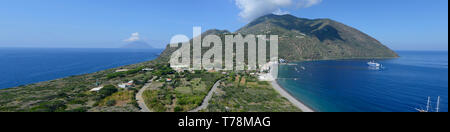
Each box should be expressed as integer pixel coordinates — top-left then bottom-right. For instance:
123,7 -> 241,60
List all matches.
279,51 -> 448,112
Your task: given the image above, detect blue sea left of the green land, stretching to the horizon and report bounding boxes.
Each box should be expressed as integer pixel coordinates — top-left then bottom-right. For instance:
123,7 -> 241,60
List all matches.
0,48 -> 162,89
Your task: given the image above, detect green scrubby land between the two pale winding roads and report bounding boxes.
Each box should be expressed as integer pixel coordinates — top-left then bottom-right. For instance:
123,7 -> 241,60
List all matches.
143,71 -> 222,112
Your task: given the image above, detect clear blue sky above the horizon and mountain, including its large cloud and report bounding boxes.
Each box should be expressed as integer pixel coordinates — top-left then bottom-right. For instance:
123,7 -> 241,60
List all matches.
0,0 -> 448,50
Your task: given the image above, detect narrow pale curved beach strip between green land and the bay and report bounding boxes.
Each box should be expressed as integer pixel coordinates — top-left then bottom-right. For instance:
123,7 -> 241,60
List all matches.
271,80 -> 315,112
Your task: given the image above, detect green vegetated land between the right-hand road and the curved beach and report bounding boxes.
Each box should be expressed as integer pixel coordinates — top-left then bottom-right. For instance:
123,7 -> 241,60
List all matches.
204,74 -> 301,112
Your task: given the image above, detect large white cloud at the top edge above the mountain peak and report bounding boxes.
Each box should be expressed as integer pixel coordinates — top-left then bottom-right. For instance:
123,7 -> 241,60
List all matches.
236,0 -> 322,20
